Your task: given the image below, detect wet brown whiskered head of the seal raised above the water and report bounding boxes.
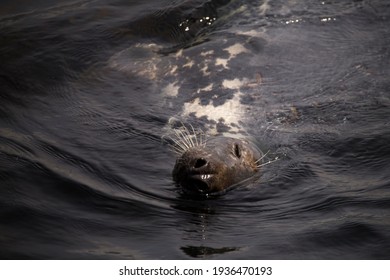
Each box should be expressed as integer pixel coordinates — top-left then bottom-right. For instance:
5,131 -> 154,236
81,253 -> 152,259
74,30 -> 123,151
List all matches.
172,126 -> 264,194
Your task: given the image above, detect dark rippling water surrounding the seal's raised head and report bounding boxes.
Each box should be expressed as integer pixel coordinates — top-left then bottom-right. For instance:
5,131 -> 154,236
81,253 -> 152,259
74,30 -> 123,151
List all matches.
0,0 -> 390,259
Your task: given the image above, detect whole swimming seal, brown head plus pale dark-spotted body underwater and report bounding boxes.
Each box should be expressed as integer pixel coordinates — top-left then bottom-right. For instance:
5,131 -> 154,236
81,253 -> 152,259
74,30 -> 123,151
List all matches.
107,0 -> 276,195
